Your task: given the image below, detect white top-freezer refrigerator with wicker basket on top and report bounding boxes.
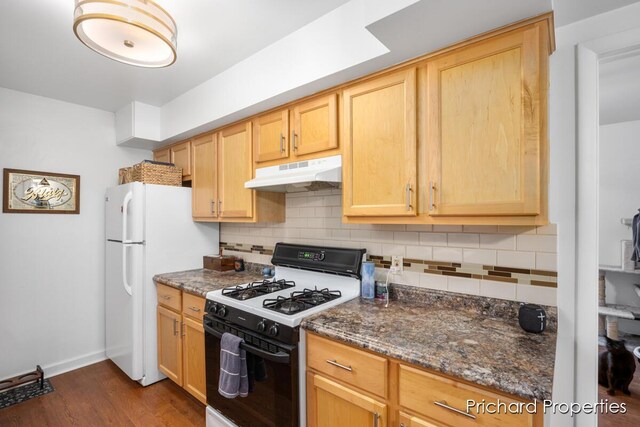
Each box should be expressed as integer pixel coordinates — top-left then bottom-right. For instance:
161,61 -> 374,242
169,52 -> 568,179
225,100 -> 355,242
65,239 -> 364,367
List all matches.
105,182 -> 220,386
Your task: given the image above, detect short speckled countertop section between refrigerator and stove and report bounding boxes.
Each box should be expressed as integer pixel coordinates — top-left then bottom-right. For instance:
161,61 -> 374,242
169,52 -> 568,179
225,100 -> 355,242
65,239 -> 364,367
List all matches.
153,263 -> 265,297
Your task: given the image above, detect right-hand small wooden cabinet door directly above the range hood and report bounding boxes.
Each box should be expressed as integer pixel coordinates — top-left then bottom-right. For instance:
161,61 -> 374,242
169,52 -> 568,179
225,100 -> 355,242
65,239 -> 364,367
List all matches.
291,93 -> 338,156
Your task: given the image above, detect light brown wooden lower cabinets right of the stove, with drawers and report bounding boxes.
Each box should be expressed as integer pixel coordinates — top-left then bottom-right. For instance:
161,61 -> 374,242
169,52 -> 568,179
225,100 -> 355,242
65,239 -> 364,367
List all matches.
306,333 -> 543,427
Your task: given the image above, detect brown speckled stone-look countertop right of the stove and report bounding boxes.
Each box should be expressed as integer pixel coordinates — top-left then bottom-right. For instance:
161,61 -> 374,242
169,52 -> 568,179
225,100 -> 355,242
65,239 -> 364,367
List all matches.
301,285 -> 557,400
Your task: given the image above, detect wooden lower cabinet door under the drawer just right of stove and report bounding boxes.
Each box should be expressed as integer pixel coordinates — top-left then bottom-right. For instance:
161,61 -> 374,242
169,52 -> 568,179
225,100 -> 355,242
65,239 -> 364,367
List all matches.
307,373 -> 387,427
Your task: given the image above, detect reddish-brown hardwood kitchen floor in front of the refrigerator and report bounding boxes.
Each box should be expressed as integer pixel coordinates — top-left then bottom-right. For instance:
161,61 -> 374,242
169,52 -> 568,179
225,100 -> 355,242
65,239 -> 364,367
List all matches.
0,360 -> 205,427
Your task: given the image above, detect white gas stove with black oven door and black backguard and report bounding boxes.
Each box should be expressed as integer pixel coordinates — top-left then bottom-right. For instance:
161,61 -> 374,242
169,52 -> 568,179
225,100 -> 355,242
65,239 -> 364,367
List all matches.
204,243 -> 365,427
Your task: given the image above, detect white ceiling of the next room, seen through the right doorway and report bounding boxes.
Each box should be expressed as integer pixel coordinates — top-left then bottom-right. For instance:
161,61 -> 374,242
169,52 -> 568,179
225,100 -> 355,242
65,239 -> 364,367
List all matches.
598,52 -> 640,125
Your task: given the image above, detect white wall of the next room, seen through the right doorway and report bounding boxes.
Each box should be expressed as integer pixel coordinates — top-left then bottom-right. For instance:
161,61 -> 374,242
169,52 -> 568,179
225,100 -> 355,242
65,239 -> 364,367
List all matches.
598,121 -> 640,334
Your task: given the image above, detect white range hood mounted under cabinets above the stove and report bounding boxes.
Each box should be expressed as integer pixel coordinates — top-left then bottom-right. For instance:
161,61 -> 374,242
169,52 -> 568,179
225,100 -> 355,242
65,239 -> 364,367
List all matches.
244,155 -> 342,193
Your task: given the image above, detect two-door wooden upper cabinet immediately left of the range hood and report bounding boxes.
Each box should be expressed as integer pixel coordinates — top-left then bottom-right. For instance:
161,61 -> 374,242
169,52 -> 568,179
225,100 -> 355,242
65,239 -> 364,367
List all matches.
191,121 -> 285,222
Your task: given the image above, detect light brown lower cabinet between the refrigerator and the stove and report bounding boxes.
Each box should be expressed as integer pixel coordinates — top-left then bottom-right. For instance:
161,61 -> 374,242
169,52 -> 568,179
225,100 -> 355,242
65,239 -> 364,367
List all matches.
157,284 -> 207,404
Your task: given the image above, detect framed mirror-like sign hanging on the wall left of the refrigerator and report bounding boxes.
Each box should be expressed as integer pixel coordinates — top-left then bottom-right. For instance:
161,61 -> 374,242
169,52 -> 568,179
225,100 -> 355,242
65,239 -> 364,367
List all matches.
2,168 -> 80,215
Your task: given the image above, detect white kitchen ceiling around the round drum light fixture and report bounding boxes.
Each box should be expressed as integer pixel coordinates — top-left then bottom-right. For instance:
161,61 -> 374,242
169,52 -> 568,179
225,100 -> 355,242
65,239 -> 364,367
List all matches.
0,0 -> 348,111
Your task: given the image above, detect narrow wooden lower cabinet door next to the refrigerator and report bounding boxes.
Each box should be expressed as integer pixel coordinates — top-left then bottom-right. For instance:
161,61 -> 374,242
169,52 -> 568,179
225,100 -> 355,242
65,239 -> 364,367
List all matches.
158,307 -> 182,385
